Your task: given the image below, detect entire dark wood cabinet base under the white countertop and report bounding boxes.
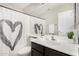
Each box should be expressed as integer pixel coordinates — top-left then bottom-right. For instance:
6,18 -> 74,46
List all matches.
31,42 -> 70,56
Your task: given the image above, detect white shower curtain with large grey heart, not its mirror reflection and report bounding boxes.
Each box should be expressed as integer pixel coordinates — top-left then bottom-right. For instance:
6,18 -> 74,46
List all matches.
0,7 -> 29,56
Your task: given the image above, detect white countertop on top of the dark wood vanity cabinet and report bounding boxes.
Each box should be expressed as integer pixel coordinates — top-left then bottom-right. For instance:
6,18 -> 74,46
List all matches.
31,38 -> 78,56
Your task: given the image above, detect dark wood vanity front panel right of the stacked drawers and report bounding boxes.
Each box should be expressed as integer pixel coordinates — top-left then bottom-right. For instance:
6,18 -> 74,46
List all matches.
45,48 -> 69,56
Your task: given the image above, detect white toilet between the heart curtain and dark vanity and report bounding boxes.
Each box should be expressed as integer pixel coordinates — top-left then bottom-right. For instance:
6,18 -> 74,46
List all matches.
17,46 -> 31,56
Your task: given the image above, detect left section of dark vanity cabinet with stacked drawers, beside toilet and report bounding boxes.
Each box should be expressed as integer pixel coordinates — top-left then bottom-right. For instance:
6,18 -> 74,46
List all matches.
31,42 -> 44,56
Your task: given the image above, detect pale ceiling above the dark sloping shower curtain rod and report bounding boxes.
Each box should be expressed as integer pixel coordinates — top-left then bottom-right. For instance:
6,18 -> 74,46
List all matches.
0,3 -> 74,19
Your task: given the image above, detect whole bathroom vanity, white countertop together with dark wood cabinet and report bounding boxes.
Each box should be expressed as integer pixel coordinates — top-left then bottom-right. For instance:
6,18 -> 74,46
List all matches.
31,39 -> 78,56
